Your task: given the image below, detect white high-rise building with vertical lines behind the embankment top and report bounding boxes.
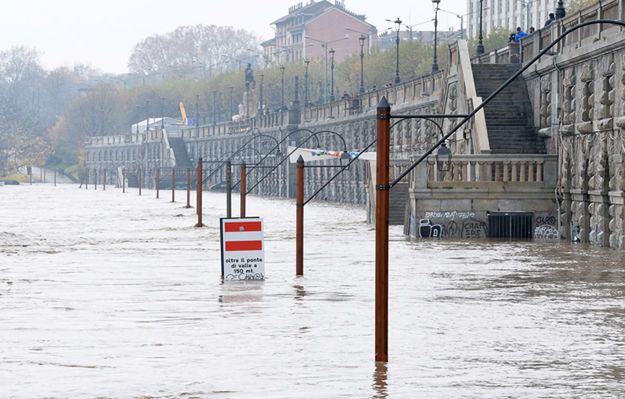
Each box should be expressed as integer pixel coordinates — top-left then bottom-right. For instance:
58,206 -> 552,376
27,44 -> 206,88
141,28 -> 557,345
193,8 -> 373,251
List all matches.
467,0 -> 557,38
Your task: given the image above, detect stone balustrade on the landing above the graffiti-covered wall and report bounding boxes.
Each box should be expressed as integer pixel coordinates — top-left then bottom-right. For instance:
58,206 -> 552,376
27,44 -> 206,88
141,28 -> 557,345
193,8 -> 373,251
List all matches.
412,154 -> 558,188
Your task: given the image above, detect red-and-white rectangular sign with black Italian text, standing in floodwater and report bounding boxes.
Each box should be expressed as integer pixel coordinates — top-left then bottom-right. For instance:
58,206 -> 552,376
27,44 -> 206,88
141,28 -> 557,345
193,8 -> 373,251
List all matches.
220,218 -> 265,280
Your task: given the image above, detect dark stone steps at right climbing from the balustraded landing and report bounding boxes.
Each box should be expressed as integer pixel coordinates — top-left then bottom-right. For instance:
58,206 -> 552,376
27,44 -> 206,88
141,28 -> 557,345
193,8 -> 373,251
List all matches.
472,64 -> 545,154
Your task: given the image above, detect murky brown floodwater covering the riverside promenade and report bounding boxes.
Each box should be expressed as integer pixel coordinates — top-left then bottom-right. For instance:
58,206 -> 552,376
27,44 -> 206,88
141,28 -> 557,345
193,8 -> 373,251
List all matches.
0,185 -> 625,399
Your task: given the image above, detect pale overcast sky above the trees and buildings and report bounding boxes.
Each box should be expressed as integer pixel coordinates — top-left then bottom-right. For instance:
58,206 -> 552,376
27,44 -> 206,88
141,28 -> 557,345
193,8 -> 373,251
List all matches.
0,0 -> 466,73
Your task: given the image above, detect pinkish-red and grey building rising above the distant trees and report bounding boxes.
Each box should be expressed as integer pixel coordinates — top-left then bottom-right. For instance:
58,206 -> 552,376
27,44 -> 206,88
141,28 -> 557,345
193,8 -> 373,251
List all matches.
261,0 -> 377,65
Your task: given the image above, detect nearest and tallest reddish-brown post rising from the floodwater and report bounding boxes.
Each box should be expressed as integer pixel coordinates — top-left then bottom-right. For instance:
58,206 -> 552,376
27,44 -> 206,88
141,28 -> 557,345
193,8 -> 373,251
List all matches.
375,97 -> 391,362
